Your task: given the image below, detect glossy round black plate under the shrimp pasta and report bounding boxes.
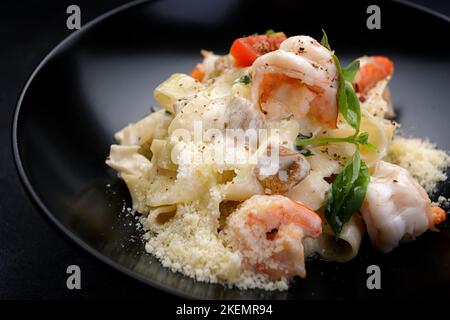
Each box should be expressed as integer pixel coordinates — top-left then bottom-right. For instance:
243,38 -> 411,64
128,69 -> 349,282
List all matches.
13,0 -> 450,299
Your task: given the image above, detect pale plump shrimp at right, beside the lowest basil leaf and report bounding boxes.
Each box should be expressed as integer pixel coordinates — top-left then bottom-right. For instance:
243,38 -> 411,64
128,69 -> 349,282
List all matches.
361,161 -> 445,253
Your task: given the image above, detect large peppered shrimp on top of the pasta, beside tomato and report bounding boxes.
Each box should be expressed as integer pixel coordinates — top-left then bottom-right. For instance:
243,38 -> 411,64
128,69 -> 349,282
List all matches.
252,36 -> 338,128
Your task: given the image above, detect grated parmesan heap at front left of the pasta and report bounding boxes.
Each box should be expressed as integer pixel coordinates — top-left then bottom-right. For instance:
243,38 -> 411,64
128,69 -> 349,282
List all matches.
141,188 -> 288,290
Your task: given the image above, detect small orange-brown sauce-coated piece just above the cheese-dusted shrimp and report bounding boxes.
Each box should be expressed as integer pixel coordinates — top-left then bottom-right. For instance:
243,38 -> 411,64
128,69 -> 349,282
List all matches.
256,146 -> 311,194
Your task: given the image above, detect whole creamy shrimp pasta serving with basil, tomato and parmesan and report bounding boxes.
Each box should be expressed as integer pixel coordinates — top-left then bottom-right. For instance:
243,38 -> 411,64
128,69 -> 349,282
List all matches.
106,30 -> 450,290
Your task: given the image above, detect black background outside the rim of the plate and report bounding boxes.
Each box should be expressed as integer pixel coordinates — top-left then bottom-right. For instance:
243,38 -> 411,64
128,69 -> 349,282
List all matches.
0,0 -> 450,299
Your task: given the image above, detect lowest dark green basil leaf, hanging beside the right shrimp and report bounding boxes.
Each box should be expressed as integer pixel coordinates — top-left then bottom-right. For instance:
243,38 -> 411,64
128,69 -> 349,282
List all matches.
325,151 -> 370,238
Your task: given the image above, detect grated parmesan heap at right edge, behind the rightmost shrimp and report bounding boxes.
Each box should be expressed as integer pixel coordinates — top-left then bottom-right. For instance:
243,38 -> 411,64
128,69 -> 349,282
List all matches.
387,137 -> 450,193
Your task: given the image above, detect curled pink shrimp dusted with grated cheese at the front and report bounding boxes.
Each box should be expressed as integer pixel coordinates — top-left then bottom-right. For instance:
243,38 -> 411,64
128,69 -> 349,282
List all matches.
225,195 -> 322,279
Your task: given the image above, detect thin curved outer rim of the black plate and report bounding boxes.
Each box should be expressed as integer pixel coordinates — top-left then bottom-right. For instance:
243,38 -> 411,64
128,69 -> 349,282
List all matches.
11,0 -> 450,299
